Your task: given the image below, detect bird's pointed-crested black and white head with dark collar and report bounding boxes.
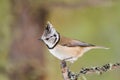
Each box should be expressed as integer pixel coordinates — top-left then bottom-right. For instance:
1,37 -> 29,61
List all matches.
41,22 -> 60,49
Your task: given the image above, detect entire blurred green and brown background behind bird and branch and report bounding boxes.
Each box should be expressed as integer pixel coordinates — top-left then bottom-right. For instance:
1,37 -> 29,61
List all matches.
0,0 -> 120,80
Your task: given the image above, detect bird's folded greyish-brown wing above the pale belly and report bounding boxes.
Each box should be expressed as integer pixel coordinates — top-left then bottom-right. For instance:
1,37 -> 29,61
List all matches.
59,37 -> 95,47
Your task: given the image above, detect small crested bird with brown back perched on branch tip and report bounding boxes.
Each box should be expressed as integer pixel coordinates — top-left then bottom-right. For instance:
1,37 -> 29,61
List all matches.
39,21 -> 109,63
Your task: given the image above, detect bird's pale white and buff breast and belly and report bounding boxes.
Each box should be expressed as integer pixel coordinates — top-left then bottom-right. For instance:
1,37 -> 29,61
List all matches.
49,45 -> 82,60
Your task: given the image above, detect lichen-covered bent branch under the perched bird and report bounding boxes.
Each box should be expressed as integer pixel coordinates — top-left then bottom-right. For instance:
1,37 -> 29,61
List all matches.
61,60 -> 120,80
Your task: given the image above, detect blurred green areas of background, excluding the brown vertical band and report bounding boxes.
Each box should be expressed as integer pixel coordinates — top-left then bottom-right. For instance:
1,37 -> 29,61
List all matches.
0,0 -> 120,80
